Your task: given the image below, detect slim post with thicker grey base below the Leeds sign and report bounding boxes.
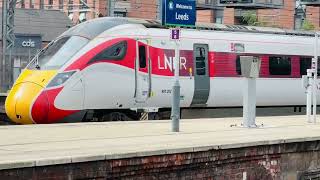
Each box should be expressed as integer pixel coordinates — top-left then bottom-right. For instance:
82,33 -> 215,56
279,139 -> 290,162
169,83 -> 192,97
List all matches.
171,40 -> 180,132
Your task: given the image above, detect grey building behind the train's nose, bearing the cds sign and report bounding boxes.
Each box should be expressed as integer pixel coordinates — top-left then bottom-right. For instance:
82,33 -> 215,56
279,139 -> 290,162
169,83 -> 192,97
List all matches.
0,8 -> 72,87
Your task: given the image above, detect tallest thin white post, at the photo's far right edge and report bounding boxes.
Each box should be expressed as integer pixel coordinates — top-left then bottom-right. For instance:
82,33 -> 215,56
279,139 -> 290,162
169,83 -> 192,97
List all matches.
312,32 -> 318,123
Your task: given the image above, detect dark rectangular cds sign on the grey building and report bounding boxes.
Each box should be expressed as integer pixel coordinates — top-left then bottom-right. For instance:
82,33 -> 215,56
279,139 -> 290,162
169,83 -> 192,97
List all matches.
14,34 -> 42,49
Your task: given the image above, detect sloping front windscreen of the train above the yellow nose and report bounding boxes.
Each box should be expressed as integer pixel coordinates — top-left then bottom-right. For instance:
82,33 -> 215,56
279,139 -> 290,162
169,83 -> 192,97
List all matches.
27,36 -> 89,70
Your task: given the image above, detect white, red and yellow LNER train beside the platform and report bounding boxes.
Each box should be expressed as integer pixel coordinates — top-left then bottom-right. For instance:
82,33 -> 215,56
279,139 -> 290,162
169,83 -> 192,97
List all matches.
5,17 -> 320,124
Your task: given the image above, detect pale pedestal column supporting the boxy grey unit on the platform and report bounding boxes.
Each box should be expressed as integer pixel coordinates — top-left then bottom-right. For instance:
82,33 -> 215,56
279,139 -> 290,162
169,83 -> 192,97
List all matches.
243,78 -> 256,127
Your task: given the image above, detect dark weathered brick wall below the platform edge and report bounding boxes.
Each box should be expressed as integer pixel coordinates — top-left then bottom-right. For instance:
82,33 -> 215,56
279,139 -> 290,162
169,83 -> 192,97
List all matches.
0,141 -> 320,180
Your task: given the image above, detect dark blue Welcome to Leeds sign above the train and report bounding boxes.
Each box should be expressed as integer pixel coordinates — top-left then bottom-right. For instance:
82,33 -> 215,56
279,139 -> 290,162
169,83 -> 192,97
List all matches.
162,0 -> 196,26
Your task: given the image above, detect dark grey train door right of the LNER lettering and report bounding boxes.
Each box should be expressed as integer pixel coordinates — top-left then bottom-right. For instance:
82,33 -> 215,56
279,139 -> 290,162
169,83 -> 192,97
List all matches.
191,44 -> 210,106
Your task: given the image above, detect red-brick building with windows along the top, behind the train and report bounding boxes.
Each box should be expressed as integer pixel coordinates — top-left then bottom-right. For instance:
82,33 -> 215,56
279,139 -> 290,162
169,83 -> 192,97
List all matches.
0,0 -> 320,29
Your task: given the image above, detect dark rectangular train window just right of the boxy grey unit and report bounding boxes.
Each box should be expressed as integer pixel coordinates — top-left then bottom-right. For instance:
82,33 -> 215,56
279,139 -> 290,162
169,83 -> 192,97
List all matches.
269,56 -> 291,75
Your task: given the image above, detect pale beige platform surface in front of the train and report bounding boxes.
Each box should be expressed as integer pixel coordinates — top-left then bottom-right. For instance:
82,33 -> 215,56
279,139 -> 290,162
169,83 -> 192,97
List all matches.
0,116 -> 320,169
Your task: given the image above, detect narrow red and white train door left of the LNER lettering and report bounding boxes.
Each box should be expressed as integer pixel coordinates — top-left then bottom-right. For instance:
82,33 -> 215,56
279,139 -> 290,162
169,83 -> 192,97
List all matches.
135,40 -> 151,103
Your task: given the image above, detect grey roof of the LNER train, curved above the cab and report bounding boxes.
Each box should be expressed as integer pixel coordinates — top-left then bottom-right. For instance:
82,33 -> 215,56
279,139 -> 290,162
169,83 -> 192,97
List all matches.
61,17 -> 315,39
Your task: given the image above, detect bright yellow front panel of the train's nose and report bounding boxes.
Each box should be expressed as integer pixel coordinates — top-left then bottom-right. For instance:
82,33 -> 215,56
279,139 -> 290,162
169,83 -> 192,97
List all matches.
5,70 -> 56,124
